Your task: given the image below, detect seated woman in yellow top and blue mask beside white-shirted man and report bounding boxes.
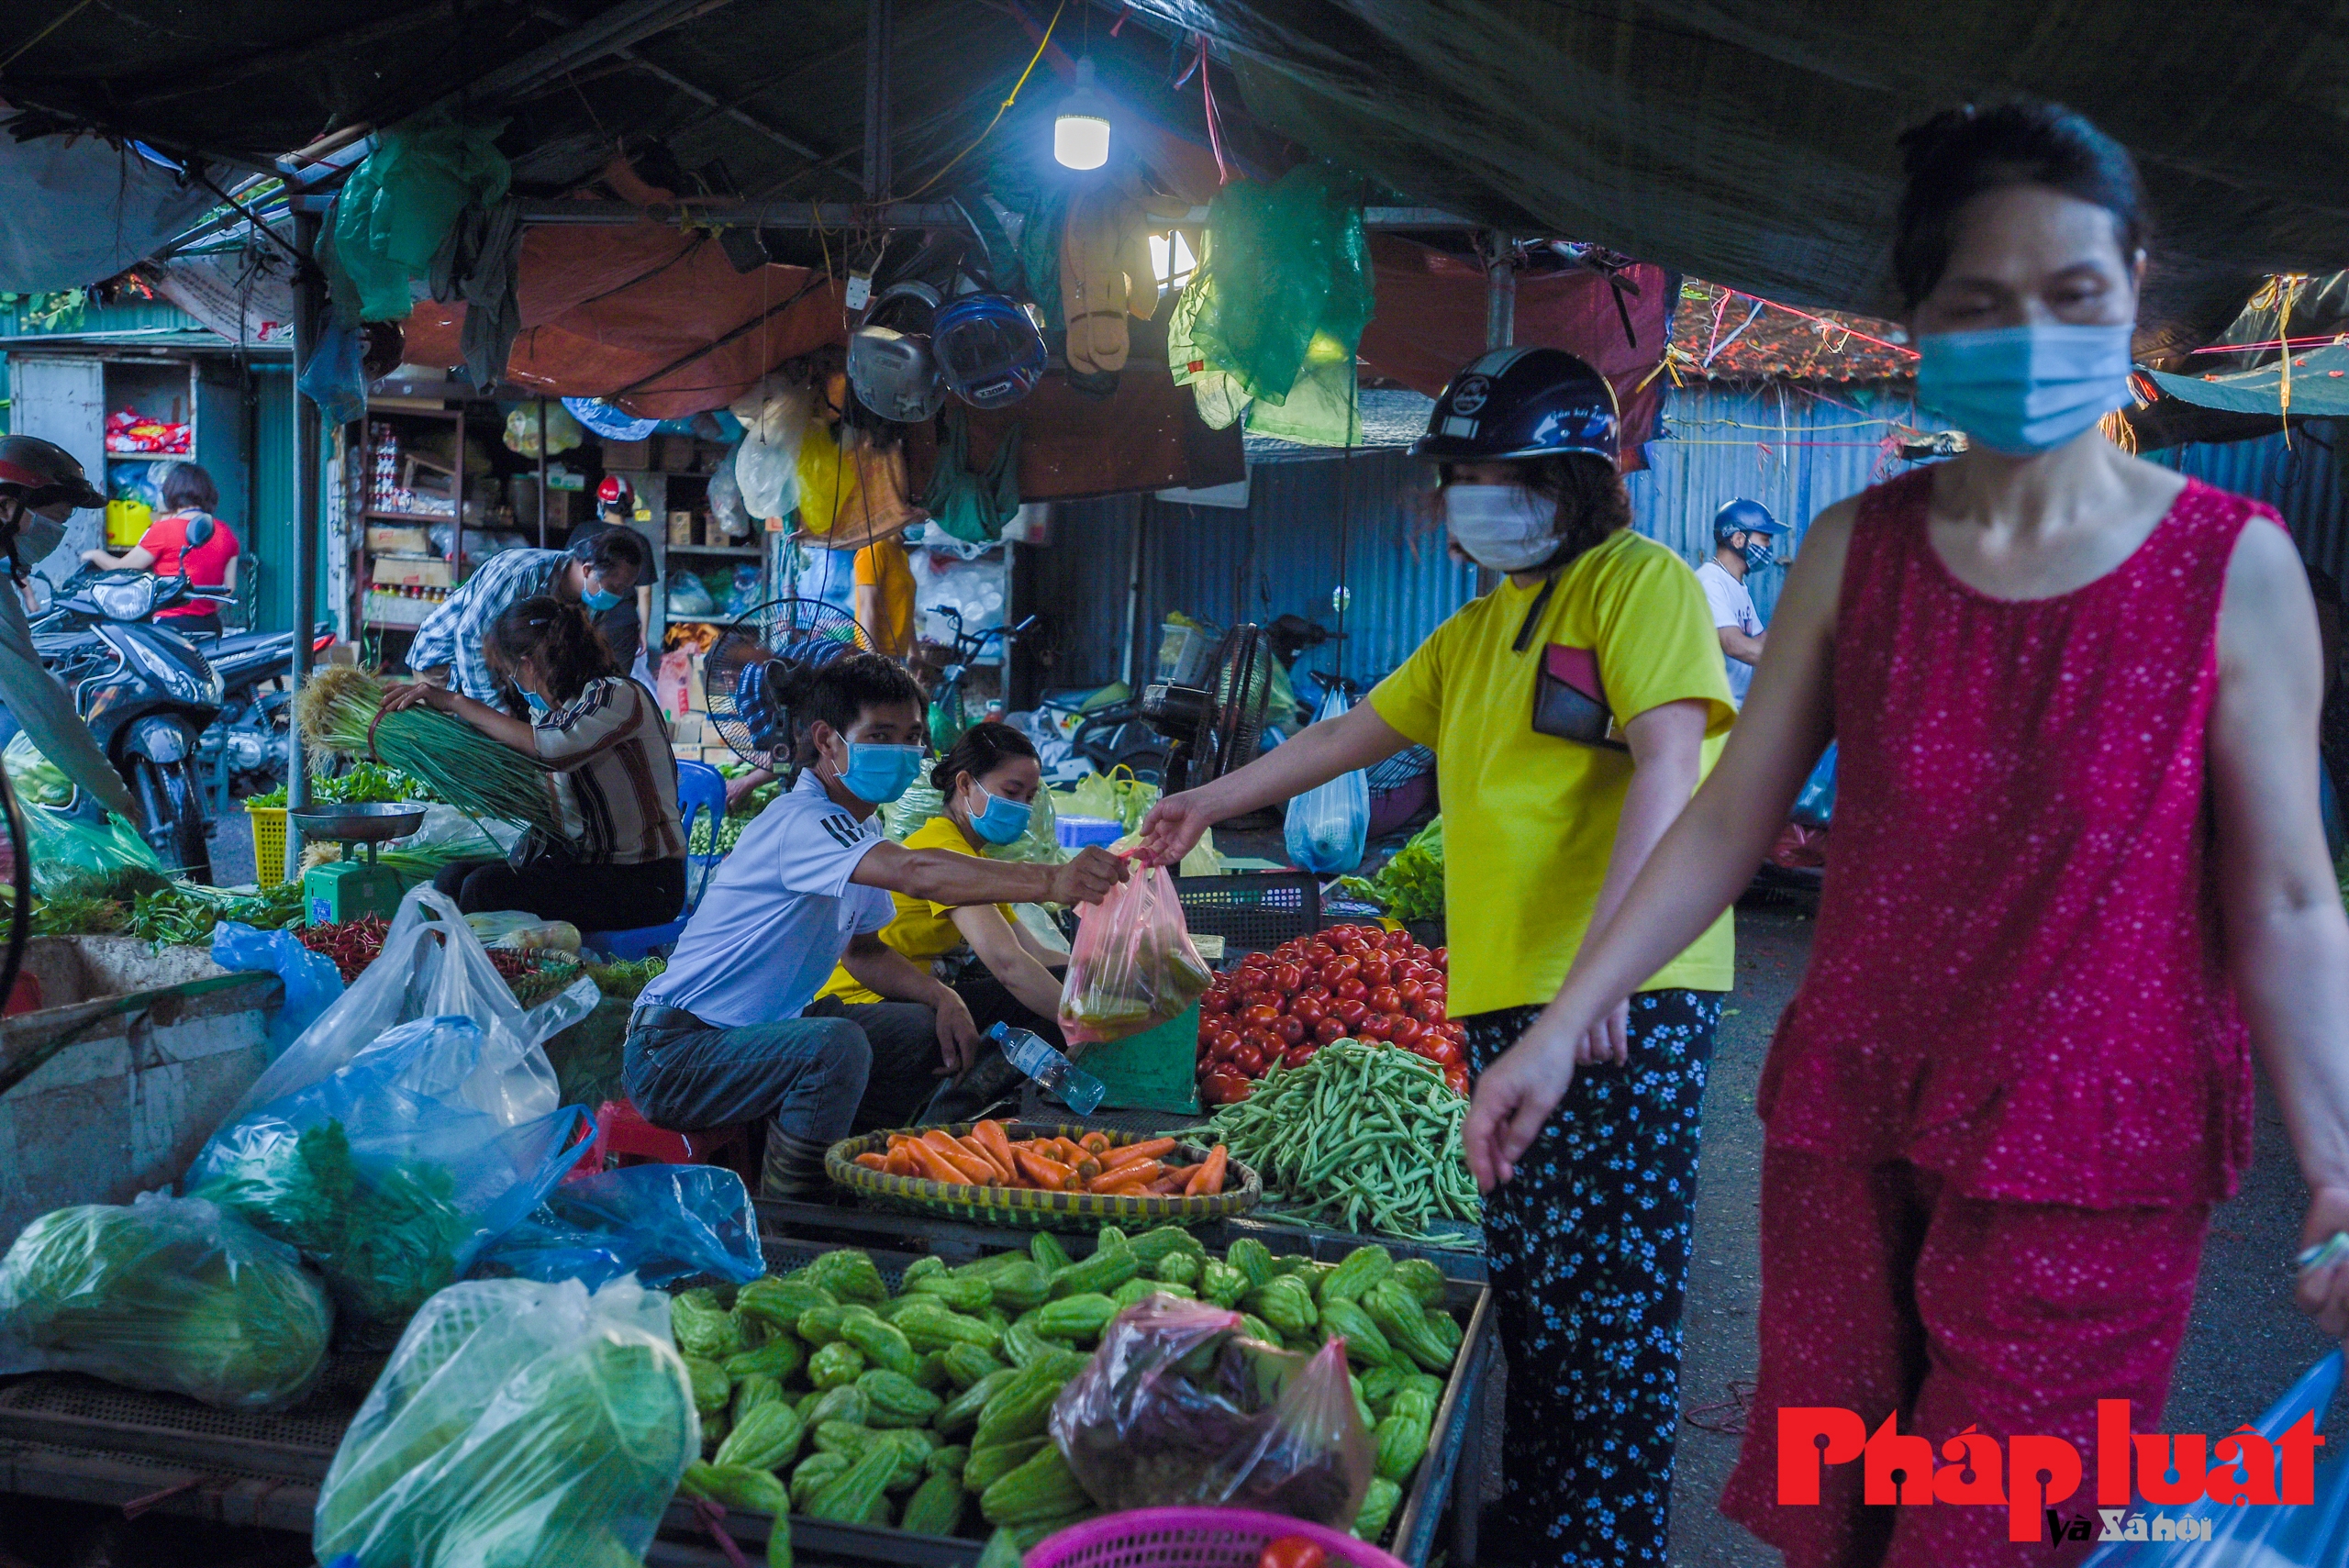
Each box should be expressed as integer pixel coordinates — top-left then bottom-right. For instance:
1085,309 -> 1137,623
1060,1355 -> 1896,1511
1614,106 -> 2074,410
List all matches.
818,723 -> 1069,1044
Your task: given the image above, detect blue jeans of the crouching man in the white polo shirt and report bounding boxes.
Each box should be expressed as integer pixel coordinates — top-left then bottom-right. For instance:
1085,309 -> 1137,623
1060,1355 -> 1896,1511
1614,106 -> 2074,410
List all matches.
620,997 -> 940,1151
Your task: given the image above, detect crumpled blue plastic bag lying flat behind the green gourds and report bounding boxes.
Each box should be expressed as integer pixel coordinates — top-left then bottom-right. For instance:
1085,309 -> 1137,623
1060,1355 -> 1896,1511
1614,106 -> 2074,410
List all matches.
474,1164 -> 766,1291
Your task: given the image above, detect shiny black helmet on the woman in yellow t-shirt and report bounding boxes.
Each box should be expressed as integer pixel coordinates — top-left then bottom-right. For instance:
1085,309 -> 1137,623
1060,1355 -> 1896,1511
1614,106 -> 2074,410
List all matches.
1412,348 -> 1623,467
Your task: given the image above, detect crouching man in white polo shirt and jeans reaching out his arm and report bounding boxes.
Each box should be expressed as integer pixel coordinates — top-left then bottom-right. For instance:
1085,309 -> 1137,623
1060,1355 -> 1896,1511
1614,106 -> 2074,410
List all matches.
622,652 -> 1128,1197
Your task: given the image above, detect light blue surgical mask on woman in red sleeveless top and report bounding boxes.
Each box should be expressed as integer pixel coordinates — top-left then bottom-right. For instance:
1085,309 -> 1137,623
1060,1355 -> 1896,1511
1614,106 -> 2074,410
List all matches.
1917,324 -> 2132,458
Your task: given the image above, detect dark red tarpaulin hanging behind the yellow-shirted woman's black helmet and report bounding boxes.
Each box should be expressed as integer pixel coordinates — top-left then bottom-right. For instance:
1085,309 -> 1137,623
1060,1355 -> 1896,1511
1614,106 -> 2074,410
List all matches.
1363,235 -> 1673,470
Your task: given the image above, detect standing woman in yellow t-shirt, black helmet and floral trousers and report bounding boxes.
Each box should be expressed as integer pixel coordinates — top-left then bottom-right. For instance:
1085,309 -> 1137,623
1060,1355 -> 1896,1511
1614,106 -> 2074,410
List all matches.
1141,348 -> 1736,1563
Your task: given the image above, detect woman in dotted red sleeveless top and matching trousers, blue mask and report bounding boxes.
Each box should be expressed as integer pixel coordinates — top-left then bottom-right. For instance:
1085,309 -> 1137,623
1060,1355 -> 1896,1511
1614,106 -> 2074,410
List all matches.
1468,106 -> 2349,1568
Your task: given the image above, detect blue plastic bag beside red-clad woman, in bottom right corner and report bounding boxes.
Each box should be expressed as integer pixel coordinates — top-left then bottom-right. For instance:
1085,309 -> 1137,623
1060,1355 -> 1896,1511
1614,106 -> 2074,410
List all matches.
2084,1350 -> 2349,1568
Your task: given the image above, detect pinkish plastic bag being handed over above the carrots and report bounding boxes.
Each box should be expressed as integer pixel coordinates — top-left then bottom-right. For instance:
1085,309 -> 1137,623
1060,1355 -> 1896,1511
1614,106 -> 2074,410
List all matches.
1060,866 -> 1215,1044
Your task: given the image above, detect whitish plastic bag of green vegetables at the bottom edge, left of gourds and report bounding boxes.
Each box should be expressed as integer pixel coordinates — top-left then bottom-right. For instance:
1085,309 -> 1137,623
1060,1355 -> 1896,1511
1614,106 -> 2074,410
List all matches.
312,1277 -> 702,1568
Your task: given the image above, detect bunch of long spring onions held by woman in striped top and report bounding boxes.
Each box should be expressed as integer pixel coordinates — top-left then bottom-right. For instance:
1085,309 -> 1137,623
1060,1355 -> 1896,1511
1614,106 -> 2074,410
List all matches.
294,667 -> 563,838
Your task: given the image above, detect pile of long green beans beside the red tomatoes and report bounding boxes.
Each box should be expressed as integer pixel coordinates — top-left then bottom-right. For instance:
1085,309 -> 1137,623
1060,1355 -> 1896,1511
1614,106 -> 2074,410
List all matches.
1182,1040 -> 1482,1241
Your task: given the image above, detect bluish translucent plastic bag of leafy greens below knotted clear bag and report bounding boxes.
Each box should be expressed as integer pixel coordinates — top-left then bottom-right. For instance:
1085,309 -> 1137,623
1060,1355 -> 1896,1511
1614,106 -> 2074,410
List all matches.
188,1014 -> 587,1336
